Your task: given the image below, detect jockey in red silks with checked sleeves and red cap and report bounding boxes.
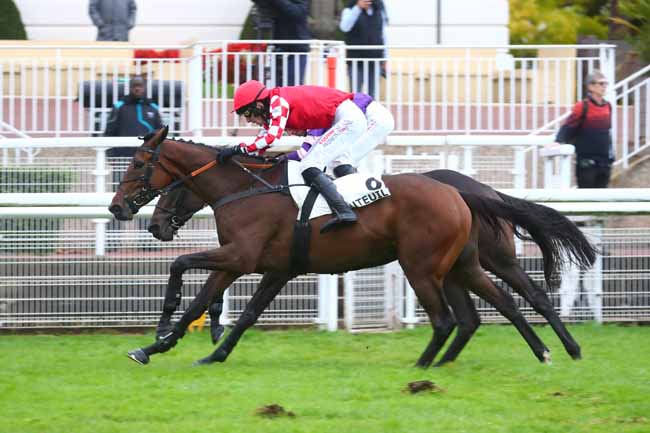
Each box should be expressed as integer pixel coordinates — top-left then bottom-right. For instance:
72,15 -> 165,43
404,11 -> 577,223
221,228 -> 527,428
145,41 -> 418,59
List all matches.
218,80 -> 367,233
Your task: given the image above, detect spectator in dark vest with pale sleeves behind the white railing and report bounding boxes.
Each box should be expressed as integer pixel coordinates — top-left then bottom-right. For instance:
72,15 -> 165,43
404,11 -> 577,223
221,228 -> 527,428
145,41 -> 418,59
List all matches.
339,0 -> 388,98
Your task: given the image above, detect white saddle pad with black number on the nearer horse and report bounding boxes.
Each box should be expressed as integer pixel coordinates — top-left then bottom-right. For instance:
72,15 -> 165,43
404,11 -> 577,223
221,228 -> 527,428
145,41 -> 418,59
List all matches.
287,161 -> 390,219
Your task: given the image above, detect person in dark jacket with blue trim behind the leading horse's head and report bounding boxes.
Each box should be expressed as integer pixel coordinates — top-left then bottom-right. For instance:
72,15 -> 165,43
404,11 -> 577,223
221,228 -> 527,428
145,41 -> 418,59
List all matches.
104,75 -> 163,158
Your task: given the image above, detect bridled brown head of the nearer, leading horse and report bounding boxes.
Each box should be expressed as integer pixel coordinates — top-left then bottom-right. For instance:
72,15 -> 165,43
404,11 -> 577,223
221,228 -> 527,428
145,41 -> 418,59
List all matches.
108,126 -> 173,221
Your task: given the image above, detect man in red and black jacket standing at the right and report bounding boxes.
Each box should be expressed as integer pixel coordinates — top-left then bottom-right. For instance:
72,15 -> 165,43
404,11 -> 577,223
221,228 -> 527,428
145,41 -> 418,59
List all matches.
555,70 -> 614,188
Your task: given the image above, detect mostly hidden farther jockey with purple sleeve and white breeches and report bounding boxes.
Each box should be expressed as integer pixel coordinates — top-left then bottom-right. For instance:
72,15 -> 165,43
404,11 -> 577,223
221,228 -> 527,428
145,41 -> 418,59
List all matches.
285,93 -> 395,177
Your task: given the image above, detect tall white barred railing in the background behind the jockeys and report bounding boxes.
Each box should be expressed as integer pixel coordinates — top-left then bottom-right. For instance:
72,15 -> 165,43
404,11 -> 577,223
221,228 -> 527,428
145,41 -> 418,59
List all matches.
0,40 -> 615,136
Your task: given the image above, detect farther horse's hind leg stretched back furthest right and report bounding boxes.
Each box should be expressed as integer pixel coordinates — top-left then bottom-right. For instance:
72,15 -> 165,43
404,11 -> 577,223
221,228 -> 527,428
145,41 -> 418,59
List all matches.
485,261 -> 581,359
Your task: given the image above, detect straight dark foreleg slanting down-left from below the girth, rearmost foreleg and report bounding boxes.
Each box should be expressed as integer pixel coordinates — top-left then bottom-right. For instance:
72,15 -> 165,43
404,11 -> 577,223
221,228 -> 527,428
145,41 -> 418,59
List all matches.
195,273 -> 294,365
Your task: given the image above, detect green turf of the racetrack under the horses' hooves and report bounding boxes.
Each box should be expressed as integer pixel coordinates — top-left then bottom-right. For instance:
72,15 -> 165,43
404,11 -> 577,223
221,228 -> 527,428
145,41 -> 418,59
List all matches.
0,325 -> 650,433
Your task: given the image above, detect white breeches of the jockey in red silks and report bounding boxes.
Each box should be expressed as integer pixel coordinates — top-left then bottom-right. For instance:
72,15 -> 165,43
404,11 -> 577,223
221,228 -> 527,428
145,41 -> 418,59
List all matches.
300,99 -> 364,171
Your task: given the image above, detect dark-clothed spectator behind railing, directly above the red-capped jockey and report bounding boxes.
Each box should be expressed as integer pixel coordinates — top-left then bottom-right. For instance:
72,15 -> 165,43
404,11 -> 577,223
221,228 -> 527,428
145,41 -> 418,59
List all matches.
254,0 -> 312,86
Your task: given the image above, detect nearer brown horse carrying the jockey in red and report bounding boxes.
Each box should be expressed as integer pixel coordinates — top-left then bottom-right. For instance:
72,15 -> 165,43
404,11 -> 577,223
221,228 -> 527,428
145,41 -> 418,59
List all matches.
109,128 -> 593,366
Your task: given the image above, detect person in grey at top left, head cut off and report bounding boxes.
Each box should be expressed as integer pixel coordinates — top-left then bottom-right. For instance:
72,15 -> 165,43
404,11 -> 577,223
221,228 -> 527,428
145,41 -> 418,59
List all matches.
88,0 -> 137,41
